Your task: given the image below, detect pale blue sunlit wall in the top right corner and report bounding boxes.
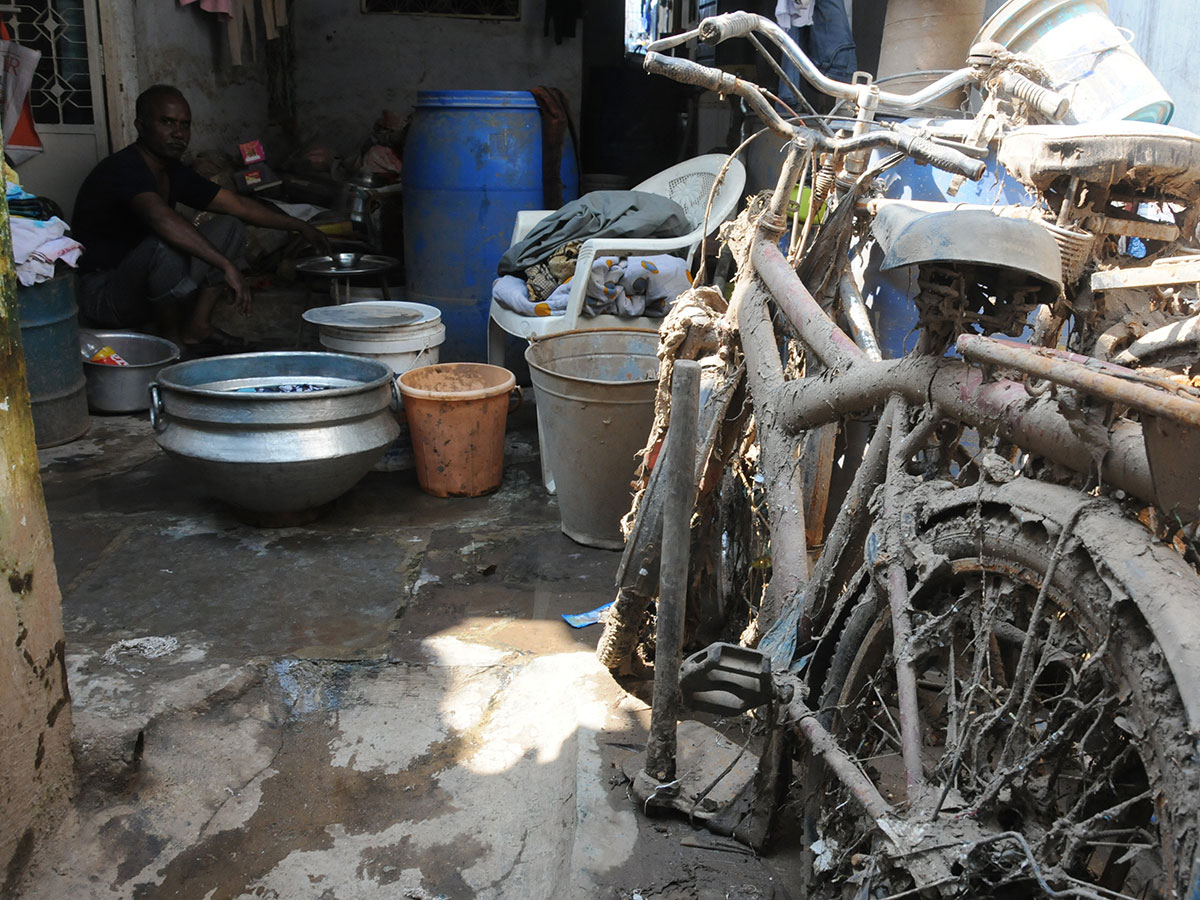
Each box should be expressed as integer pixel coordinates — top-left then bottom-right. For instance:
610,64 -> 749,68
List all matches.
1109,0 -> 1200,132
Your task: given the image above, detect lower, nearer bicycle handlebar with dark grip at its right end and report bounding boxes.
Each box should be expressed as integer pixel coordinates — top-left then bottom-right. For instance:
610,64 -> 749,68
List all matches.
644,52 -> 985,179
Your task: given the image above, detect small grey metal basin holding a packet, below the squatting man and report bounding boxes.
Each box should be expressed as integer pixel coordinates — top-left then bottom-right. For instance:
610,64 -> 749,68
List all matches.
79,330 -> 179,413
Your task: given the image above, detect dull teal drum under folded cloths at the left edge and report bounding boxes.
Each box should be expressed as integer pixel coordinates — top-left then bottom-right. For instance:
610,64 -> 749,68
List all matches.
17,272 -> 90,448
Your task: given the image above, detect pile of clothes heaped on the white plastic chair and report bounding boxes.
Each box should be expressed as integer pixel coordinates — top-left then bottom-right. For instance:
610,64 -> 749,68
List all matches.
492,191 -> 691,317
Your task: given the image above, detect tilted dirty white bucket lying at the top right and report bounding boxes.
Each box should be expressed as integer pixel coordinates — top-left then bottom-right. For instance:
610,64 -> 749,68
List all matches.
976,0 -> 1175,125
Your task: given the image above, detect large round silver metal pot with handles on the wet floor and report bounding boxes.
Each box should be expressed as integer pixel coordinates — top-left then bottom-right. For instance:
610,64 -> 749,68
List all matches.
150,352 -> 400,514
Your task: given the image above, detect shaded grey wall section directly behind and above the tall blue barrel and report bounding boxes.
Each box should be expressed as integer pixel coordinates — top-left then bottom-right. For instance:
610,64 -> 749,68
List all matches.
292,6 -> 583,154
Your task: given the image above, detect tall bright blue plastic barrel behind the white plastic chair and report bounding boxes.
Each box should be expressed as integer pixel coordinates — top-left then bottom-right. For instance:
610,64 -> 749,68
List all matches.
404,91 -> 542,362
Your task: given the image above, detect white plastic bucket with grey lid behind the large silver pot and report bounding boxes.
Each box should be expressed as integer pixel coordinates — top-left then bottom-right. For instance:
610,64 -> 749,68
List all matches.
304,300 -> 446,376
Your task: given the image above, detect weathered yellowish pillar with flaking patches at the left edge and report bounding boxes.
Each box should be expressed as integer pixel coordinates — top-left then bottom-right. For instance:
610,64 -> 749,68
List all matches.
0,153 -> 72,896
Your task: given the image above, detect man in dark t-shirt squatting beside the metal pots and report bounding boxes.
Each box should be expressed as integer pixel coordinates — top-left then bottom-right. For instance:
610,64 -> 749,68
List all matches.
72,84 -> 330,355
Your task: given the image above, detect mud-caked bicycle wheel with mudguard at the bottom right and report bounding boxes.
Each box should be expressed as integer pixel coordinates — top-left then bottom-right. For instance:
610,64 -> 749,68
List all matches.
804,482 -> 1200,898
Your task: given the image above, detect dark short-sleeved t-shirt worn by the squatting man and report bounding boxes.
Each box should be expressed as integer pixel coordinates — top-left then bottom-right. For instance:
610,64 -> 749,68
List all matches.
71,145 -> 221,272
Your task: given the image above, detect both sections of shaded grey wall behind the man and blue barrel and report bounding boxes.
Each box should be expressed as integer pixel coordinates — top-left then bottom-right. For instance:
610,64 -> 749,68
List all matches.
121,0 -> 582,165
